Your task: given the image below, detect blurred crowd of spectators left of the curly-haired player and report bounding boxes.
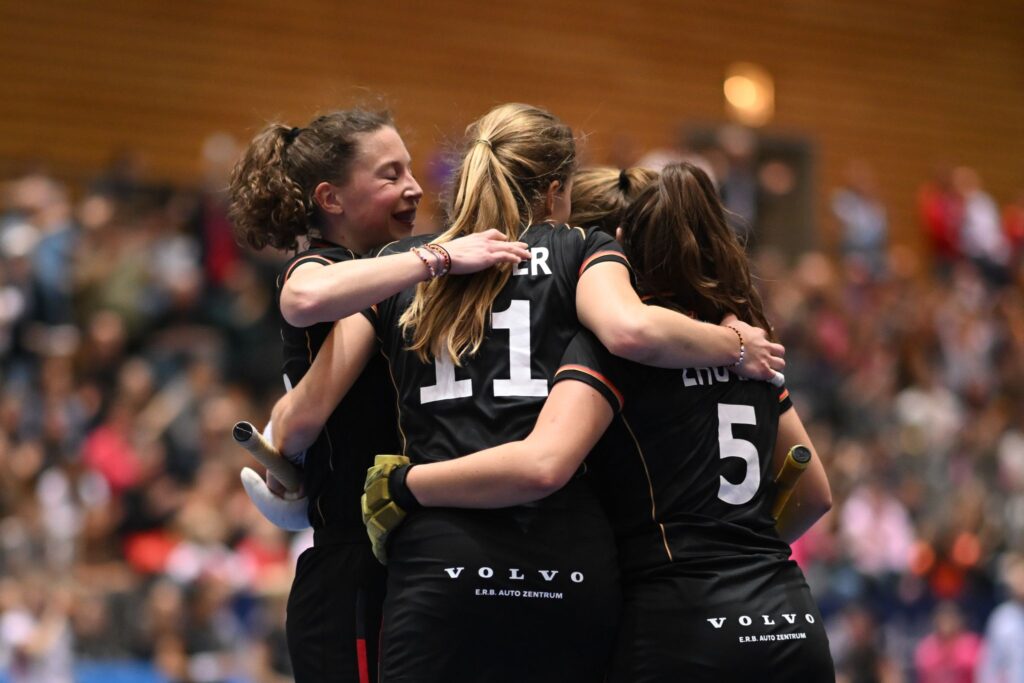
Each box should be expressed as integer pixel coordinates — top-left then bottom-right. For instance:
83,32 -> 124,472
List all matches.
0,140 -> 296,683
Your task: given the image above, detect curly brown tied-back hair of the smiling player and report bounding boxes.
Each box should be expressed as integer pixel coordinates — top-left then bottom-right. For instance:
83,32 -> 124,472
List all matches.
228,109 -> 394,250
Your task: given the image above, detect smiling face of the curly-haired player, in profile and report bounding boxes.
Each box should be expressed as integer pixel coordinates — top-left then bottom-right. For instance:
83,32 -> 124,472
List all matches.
326,126 -> 423,252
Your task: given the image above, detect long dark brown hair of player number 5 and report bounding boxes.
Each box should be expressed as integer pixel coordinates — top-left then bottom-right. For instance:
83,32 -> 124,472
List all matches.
622,163 -> 771,330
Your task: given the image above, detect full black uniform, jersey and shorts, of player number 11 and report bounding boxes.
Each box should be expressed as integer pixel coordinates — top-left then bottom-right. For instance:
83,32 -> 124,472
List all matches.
367,223 -> 625,683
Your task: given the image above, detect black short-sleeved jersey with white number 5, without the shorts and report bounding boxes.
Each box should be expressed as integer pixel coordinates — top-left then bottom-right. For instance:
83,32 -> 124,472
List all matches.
555,331 -> 793,573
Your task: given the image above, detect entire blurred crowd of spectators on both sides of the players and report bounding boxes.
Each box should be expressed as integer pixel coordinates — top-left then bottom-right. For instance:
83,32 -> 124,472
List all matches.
0,131 -> 1024,683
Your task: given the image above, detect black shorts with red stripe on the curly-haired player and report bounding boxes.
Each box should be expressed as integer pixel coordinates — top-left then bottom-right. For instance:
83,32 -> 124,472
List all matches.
285,529 -> 386,683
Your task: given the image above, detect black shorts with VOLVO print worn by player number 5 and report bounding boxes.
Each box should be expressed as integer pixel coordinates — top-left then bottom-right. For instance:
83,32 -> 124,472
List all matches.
608,562 -> 836,683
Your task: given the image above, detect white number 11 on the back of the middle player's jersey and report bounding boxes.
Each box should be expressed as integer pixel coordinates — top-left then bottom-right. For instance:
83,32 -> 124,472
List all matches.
420,299 -> 548,403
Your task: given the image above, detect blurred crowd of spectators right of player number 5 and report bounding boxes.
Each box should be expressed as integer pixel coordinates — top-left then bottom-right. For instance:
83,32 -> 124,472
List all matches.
774,162 -> 1024,683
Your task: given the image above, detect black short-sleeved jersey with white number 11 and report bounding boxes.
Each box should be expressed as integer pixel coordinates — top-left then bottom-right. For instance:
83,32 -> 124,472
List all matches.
366,223 -> 628,463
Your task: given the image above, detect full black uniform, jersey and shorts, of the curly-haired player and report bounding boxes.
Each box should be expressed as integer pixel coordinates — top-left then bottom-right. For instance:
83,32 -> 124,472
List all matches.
278,240 -> 397,683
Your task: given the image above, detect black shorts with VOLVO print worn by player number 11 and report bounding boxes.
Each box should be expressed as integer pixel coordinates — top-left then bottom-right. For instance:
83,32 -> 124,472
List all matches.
381,482 -> 621,683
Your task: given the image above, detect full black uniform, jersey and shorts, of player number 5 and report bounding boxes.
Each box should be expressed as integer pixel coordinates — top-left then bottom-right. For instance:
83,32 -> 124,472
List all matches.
555,323 -> 835,683
